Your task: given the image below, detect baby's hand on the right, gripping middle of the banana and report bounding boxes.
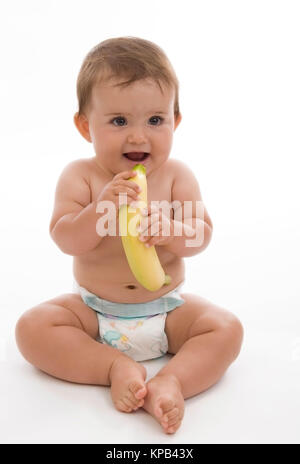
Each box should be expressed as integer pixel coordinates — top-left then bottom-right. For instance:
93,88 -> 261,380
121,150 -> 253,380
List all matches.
137,204 -> 174,247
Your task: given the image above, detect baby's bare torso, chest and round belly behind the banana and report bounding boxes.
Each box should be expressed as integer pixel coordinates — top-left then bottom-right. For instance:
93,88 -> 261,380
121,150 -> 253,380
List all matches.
54,158 -> 184,303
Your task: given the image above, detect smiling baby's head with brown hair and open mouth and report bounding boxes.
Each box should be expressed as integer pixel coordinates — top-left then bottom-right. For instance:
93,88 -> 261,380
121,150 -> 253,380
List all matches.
74,37 -> 181,175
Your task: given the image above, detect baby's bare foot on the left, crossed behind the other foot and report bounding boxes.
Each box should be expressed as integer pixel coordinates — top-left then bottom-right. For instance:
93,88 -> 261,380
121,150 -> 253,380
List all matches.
109,355 -> 147,412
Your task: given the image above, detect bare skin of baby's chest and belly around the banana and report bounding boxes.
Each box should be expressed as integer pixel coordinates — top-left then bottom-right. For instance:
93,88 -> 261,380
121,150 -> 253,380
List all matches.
73,163 -> 183,302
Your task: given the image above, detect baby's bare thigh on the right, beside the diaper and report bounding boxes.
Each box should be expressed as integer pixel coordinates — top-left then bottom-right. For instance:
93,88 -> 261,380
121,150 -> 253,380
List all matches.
165,293 -> 239,354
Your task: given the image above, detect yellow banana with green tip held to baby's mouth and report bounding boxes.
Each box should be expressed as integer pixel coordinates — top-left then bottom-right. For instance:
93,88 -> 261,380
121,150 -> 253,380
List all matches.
119,164 -> 172,292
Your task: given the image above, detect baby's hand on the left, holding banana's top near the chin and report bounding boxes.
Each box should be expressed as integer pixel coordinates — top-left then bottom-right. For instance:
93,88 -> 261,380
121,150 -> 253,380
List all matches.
97,171 -> 141,211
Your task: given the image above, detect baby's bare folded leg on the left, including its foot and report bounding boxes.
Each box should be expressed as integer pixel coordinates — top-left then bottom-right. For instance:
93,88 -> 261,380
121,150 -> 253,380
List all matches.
16,293 -> 147,412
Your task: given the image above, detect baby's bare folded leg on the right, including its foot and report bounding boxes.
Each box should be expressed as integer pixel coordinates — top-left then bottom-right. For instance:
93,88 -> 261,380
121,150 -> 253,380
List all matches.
144,294 -> 243,433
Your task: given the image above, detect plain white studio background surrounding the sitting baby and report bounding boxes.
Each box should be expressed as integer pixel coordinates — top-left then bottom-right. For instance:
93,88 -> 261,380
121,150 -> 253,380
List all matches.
0,0 -> 300,443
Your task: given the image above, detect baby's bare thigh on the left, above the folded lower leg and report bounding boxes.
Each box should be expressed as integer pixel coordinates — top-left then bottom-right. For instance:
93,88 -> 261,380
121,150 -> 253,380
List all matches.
16,293 -> 99,339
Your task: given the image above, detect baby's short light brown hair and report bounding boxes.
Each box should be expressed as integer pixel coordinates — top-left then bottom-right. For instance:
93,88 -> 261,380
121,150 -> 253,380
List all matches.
77,37 -> 180,121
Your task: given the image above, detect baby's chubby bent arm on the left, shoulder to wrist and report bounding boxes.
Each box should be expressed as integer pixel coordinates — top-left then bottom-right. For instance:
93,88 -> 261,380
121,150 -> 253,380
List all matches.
49,160 -> 103,256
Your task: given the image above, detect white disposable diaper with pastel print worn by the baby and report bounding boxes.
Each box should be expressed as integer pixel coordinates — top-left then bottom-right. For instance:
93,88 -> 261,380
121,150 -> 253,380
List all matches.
74,281 -> 185,361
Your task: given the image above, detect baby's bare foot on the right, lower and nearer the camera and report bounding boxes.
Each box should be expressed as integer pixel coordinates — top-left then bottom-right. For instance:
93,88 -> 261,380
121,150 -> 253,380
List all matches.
143,374 -> 184,433
